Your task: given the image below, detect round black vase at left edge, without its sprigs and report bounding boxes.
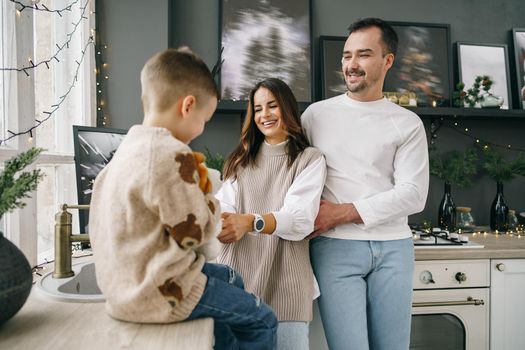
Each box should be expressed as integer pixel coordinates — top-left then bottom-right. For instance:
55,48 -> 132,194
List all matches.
0,232 -> 33,325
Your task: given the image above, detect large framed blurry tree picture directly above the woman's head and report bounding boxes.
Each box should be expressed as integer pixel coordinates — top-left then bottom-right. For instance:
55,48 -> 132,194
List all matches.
219,0 -> 313,102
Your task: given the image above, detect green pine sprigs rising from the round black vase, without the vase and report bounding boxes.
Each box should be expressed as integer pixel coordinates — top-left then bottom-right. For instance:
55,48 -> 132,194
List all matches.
0,147 -> 44,217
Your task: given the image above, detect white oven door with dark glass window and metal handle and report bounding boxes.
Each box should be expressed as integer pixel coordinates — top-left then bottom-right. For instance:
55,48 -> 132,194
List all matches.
410,288 -> 490,350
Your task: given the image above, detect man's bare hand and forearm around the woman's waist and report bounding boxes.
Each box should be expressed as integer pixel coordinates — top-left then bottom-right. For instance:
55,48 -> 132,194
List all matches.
306,199 -> 363,239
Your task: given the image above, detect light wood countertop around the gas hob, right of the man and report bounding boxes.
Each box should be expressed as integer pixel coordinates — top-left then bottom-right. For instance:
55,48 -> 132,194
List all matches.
415,233 -> 525,260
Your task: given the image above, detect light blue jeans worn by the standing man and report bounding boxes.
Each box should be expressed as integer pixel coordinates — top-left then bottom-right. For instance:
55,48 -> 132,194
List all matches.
310,236 -> 414,350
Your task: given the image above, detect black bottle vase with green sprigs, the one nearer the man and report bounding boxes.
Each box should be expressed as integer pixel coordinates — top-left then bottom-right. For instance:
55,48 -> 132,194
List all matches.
429,147 -> 478,231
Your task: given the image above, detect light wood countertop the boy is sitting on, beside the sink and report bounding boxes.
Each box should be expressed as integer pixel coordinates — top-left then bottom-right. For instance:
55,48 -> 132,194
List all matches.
0,256 -> 213,350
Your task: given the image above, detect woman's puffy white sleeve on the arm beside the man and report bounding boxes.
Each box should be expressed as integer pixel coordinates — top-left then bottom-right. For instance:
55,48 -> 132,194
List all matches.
272,157 -> 326,241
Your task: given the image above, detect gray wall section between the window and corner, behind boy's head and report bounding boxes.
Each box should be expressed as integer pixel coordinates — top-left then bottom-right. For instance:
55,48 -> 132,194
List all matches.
96,0 -> 168,129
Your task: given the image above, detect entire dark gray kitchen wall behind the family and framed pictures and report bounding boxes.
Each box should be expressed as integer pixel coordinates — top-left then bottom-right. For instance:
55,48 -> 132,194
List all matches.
101,0 -> 525,224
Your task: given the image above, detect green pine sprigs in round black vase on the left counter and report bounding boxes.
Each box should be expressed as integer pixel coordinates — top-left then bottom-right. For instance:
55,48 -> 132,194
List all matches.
0,148 -> 43,325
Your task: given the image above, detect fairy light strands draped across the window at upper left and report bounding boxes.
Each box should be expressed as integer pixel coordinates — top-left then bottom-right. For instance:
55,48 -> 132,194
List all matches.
0,0 -> 109,145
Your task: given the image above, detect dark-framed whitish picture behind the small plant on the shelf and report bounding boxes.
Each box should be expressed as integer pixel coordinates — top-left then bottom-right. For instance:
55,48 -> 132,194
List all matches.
457,42 -> 512,109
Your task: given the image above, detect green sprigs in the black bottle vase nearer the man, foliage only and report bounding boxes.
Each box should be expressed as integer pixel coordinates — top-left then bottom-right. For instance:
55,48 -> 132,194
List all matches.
429,147 -> 478,187
